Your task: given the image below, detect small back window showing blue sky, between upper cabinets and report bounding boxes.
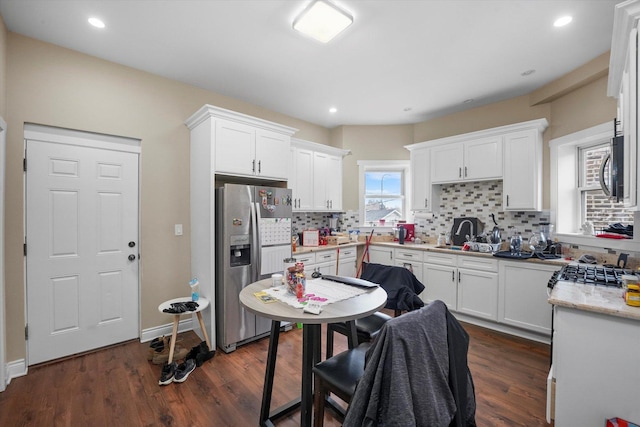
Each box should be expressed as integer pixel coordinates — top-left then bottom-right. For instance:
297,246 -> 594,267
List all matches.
358,160 -> 410,227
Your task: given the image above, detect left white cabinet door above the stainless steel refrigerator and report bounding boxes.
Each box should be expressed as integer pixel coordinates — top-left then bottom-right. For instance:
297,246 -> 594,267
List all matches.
215,120 -> 255,175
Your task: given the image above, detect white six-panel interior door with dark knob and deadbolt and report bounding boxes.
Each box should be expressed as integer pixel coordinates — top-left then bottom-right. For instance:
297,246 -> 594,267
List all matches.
26,135 -> 139,365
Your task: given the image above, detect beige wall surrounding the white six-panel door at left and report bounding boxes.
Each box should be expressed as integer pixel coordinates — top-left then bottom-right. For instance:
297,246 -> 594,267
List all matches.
5,33 -> 330,361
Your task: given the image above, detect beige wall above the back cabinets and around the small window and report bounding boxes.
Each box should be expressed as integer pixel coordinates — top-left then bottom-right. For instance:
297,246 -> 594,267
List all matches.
332,72 -> 616,214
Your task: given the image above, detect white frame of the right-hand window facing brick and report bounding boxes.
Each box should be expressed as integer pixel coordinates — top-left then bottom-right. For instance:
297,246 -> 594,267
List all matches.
549,122 -> 640,251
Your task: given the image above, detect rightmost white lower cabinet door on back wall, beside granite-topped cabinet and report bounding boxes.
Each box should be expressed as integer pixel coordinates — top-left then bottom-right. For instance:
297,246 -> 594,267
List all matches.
498,261 -> 560,335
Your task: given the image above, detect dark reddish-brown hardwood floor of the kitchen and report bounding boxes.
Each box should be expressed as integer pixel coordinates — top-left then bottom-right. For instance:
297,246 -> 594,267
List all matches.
0,324 -> 549,427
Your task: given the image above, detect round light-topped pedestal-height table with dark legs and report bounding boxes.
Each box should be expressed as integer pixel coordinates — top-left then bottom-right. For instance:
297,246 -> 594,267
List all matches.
240,279 -> 387,427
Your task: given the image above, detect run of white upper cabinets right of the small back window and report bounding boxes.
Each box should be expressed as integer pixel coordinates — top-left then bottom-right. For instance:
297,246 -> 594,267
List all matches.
405,119 -> 548,212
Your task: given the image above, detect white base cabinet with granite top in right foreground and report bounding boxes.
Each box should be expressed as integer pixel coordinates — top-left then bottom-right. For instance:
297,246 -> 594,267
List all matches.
547,281 -> 640,427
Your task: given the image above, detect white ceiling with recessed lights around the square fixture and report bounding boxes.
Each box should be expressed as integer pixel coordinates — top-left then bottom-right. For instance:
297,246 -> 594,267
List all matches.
0,0 -> 620,128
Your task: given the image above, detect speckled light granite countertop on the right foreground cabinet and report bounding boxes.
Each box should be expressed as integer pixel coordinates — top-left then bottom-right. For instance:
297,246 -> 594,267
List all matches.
549,281 -> 640,320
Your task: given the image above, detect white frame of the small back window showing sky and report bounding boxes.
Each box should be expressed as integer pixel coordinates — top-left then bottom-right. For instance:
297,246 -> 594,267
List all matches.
357,160 -> 413,230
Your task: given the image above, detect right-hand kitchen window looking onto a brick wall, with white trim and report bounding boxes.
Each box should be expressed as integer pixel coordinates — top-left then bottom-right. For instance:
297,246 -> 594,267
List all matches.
549,123 -> 640,249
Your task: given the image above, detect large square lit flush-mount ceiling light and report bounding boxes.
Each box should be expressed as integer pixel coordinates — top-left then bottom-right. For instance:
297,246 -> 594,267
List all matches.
293,0 -> 353,43
